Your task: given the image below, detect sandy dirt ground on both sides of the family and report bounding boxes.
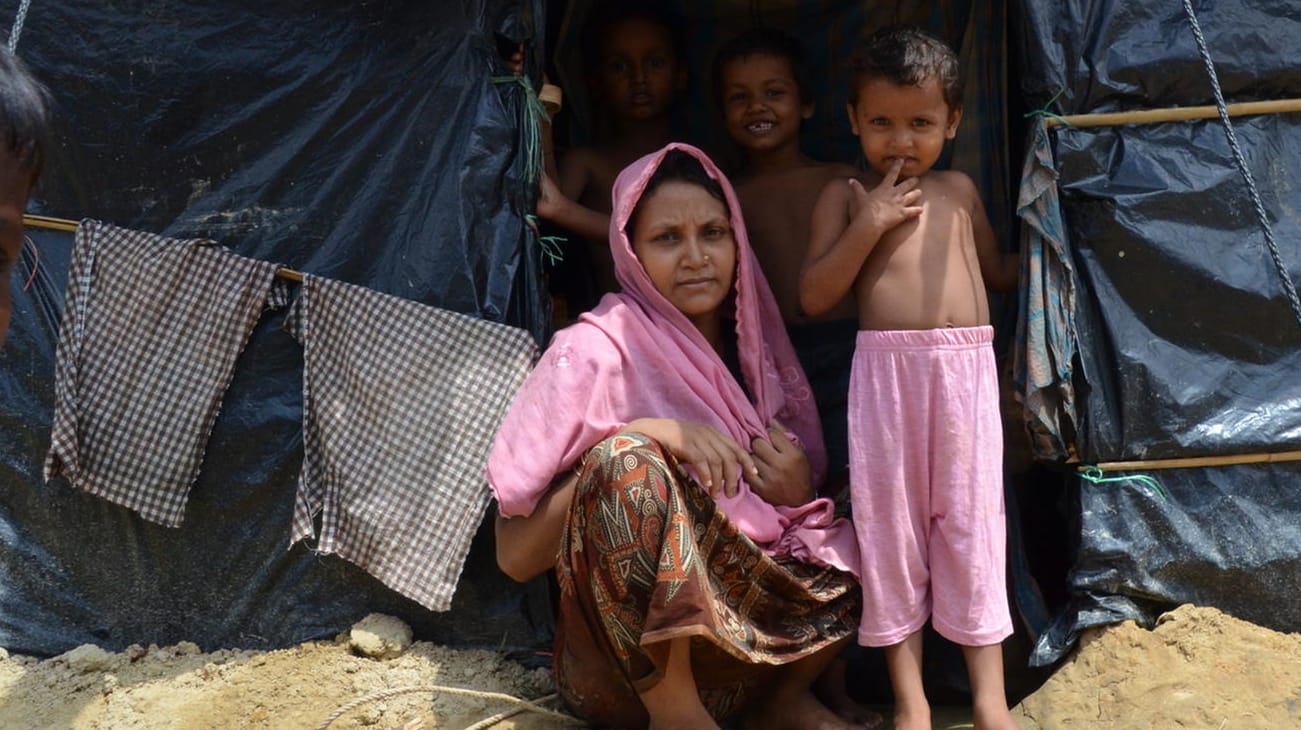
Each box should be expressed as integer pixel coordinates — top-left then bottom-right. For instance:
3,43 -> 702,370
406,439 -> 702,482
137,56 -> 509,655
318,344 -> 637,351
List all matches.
0,606 -> 1301,730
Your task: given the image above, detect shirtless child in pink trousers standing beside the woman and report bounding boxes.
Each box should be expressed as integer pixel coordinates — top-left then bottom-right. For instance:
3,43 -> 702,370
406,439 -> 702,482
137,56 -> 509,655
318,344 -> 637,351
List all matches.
800,27 -> 1017,729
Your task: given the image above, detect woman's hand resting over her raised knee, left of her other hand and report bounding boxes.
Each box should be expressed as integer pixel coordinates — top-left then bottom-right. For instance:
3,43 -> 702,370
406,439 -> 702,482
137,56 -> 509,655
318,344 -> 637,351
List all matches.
623,418 -> 758,500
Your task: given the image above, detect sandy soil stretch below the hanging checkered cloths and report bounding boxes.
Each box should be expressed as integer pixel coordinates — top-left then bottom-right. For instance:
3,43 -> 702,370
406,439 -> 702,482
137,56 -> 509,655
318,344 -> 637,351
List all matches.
0,624 -> 574,730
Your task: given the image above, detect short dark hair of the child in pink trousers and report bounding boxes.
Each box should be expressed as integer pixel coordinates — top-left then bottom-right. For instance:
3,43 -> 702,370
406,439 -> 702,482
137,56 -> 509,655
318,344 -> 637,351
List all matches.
850,25 -> 963,111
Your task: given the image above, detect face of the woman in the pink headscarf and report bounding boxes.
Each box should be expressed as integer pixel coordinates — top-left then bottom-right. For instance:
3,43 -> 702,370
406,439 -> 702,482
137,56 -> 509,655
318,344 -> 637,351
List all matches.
628,180 -> 736,329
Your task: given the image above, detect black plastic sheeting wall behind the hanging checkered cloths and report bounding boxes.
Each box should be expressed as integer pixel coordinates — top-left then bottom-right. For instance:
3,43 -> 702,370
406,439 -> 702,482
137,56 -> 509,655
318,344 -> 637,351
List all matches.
0,0 -> 549,655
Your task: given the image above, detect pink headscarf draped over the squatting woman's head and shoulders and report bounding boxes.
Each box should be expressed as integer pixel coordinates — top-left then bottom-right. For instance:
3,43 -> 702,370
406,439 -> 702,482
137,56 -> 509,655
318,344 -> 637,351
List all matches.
488,143 -> 859,574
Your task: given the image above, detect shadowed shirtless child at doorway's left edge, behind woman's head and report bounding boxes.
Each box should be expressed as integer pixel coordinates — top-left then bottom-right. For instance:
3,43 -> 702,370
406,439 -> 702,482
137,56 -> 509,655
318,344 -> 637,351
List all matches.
537,3 -> 687,295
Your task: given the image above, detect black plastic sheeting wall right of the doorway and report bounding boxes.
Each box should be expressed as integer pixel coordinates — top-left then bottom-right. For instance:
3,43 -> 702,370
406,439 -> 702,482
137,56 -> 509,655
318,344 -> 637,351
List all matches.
1019,0 -> 1301,661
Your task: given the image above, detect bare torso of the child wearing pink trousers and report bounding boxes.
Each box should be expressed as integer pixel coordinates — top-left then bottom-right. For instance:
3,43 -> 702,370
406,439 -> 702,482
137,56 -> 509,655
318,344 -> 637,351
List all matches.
848,166 -> 989,329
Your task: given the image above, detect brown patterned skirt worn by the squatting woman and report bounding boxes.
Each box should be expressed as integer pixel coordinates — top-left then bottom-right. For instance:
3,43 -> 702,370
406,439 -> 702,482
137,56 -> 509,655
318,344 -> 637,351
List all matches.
556,433 -> 861,729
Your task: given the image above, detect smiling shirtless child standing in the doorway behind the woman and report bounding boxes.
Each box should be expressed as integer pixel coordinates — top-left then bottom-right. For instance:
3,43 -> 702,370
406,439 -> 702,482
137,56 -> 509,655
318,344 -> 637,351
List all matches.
713,29 -> 882,727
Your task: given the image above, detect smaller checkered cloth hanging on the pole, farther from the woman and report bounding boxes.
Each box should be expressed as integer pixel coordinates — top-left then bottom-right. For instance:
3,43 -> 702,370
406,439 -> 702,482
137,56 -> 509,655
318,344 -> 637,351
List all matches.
44,220 -> 288,527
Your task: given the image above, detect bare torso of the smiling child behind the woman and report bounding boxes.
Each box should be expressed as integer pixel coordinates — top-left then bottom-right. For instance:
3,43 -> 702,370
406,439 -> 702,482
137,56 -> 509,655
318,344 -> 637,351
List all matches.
736,163 -> 856,324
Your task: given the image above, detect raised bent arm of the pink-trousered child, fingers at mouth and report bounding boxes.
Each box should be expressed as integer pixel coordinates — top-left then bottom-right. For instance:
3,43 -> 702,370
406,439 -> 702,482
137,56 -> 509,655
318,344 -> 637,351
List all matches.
800,163 -> 921,316
